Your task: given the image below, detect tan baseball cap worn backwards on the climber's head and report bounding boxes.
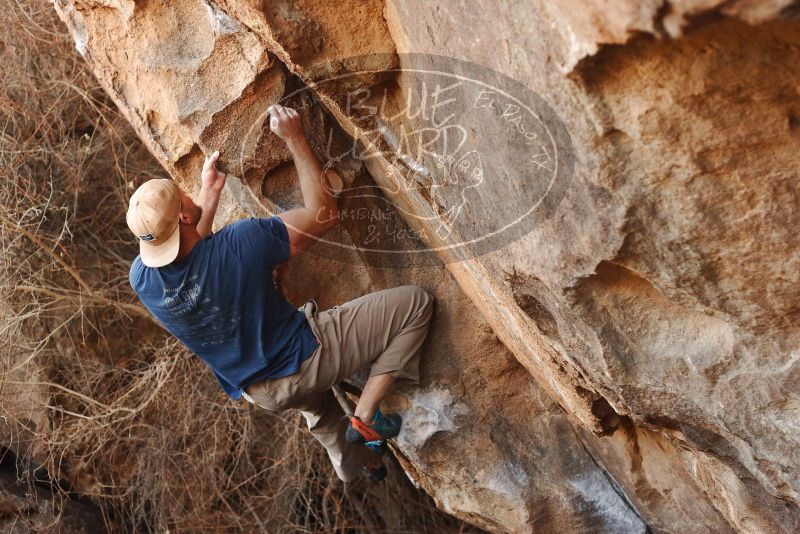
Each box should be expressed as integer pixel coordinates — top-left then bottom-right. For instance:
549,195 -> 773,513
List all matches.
125,178 -> 181,267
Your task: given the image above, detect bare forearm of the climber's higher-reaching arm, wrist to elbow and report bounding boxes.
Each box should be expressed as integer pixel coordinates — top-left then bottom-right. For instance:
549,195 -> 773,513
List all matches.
286,135 -> 339,226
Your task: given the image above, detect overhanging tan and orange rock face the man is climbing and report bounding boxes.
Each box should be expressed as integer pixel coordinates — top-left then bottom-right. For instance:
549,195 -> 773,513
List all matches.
54,0 -> 800,532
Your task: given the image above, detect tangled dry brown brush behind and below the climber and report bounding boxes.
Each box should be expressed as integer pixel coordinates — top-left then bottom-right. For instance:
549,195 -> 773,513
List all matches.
0,0 -> 476,532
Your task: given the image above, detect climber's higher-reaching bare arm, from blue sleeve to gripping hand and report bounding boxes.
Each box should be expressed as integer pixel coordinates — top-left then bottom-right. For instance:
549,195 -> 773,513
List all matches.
269,104 -> 339,256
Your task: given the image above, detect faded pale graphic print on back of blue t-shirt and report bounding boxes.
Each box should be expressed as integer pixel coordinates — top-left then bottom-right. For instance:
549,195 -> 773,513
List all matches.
163,274 -> 241,347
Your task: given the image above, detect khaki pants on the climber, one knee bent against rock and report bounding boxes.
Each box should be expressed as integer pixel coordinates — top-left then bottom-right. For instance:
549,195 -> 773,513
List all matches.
244,285 -> 433,482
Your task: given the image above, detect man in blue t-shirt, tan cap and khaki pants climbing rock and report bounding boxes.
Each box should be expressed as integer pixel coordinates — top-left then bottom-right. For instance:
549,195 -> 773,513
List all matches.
127,104 -> 433,481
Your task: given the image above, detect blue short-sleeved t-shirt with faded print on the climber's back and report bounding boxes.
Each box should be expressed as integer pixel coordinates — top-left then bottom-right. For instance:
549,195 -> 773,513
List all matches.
129,217 -> 319,399
